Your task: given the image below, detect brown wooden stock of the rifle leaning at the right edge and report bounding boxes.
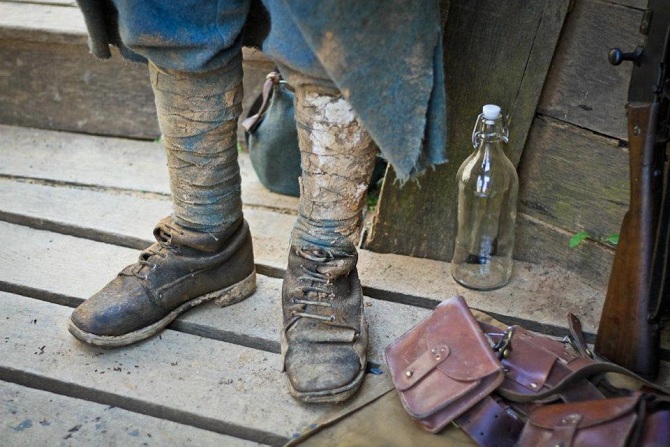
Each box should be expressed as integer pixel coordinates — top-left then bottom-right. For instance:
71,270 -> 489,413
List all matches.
595,102 -> 665,378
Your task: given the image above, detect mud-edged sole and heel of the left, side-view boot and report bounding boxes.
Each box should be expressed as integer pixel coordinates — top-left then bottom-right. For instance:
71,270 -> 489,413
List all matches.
68,270 -> 256,348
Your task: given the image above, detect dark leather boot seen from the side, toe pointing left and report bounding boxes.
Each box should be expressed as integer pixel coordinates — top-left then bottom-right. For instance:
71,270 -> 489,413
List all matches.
68,218 -> 256,348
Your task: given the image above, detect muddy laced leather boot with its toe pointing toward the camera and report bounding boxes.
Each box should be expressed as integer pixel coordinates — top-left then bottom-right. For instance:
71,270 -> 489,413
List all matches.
282,246 -> 368,402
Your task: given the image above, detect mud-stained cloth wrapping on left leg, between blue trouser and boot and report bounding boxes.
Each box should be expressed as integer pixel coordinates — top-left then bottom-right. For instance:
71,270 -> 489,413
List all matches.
149,54 -> 243,232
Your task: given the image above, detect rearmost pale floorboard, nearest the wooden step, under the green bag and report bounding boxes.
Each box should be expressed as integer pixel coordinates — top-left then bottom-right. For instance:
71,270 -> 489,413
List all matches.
0,125 -> 298,213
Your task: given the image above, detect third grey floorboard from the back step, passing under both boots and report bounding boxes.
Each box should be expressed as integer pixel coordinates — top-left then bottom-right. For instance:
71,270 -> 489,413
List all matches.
0,222 -> 436,363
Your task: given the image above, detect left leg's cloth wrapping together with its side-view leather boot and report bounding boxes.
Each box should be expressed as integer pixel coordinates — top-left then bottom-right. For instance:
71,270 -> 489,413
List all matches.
69,54 -> 255,347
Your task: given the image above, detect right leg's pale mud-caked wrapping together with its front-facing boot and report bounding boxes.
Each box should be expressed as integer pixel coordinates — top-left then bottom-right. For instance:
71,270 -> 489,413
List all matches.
281,87 -> 377,402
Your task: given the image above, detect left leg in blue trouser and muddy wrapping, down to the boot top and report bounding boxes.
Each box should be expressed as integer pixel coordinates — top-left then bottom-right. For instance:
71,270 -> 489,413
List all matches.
113,0 -> 250,232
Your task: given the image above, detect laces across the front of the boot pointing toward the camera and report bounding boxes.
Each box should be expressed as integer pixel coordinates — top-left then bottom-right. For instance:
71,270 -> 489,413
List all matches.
291,248 -> 351,323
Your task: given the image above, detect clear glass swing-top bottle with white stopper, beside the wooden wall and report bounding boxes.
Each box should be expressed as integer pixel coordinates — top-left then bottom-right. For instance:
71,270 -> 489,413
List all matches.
451,104 -> 519,290
